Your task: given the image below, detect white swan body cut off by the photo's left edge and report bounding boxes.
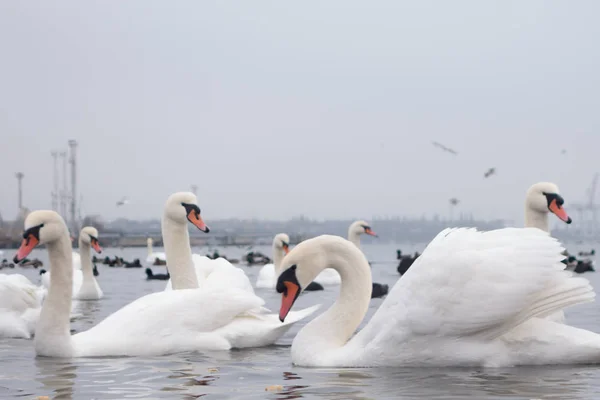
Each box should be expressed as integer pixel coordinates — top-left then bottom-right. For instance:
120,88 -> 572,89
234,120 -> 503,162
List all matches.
0,274 -> 46,339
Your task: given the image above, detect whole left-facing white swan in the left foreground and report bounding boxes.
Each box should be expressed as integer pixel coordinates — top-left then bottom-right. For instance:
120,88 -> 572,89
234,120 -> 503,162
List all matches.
15,209 -> 314,357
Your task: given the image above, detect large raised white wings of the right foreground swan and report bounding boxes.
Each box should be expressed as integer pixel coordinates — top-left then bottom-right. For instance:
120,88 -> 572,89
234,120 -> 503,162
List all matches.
355,228 -> 595,347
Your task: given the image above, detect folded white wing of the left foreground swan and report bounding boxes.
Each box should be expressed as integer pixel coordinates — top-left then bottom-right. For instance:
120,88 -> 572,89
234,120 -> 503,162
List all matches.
73,289 -> 264,356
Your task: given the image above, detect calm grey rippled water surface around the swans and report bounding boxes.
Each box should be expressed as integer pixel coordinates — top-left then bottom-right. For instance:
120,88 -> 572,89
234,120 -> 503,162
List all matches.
0,241 -> 600,399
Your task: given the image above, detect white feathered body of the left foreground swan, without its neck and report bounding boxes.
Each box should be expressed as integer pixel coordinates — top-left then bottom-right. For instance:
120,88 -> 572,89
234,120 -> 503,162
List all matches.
72,288 -> 313,356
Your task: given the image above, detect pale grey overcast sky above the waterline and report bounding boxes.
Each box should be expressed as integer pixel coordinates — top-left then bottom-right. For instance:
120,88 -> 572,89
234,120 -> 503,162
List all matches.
0,0 -> 600,224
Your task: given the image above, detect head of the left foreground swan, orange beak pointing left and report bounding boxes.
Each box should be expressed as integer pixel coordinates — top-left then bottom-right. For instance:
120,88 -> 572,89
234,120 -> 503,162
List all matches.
13,210 -> 70,263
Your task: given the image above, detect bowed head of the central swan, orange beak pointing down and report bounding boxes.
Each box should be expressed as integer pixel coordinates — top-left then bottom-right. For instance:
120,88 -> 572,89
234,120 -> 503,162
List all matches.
275,235 -> 360,322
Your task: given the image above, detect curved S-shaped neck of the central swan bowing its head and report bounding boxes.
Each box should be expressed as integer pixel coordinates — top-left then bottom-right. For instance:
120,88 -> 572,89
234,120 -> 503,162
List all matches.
292,247 -> 372,354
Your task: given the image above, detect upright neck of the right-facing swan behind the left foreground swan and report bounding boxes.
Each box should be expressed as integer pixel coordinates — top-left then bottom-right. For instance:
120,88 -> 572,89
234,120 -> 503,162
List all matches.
162,216 -> 198,290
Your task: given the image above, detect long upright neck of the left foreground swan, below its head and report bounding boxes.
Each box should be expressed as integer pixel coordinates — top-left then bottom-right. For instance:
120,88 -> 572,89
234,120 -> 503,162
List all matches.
35,235 -> 73,353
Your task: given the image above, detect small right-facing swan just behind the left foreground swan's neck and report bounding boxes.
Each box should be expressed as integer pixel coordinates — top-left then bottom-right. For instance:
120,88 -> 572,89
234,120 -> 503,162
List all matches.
42,226 -> 104,300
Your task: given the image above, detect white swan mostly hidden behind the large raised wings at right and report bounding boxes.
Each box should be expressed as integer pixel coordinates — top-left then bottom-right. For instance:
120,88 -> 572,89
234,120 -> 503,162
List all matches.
525,182 -> 572,323
